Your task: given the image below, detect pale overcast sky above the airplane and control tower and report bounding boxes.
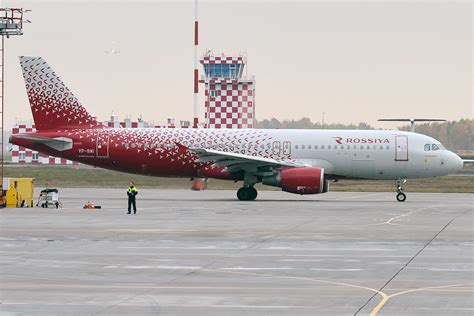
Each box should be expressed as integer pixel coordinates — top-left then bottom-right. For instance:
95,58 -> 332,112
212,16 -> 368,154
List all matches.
0,0 -> 473,128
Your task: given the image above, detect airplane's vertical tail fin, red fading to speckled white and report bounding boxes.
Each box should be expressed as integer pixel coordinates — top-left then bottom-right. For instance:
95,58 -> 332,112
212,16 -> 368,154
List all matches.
20,56 -> 101,130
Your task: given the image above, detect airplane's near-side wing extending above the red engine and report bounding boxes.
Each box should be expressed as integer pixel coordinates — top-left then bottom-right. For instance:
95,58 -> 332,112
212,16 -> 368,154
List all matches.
188,148 -> 311,173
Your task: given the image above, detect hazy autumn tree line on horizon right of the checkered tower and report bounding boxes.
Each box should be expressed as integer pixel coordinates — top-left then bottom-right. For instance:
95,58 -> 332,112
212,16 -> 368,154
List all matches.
256,117 -> 474,150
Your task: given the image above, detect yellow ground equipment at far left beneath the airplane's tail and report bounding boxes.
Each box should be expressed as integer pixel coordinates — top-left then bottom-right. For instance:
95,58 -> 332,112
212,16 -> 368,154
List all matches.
3,178 -> 35,207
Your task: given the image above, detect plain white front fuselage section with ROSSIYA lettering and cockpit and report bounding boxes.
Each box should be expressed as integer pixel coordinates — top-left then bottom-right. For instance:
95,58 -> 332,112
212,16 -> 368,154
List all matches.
258,130 -> 463,179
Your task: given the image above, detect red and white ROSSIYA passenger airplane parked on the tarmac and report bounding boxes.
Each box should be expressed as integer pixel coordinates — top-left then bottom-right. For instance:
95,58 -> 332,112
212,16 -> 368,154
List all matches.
10,56 -> 463,202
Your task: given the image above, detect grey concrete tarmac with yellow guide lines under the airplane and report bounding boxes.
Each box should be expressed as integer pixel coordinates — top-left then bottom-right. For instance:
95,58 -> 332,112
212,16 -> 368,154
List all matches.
0,188 -> 474,316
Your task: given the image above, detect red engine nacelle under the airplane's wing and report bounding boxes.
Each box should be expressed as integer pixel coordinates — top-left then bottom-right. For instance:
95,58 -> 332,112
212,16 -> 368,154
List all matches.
262,167 -> 329,194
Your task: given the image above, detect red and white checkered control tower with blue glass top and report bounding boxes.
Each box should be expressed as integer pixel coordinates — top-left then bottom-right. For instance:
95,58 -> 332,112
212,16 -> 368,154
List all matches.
201,51 -> 255,128
